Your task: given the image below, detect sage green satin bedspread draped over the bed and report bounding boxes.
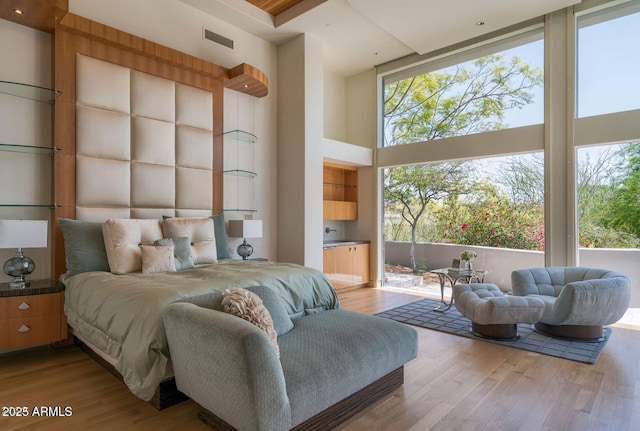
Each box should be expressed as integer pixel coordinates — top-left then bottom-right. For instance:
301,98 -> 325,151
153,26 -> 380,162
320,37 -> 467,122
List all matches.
64,260 -> 339,400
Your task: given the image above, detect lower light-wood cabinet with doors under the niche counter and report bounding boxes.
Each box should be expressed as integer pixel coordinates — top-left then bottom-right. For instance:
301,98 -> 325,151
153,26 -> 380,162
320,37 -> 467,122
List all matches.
322,241 -> 370,290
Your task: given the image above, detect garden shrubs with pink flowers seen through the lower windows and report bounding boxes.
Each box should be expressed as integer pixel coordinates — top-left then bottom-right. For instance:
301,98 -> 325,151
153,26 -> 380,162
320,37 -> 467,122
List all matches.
385,144 -> 640,250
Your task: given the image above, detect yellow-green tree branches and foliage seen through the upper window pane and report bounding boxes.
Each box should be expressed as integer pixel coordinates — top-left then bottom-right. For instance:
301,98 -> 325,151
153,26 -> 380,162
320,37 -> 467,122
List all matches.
384,55 -> 543,146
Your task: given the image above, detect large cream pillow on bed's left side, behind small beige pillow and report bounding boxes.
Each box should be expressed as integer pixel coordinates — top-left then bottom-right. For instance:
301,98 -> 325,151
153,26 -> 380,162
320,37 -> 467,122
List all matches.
102,219 -> 162,274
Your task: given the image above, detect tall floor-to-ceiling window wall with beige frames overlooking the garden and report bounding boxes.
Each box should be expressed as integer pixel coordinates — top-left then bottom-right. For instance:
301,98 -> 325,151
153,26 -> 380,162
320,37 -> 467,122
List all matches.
377,0 -> 640,303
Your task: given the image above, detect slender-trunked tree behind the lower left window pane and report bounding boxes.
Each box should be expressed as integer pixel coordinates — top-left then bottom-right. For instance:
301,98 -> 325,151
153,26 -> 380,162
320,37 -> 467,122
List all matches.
384,162 -> 468,271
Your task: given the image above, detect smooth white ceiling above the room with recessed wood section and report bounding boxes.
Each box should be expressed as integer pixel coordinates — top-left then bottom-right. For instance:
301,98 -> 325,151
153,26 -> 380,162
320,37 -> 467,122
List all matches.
180,0 -> 581,76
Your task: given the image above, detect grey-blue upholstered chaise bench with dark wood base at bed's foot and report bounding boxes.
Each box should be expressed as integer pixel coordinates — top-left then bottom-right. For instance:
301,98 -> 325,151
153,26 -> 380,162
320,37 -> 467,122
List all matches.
164,303 -> 418,431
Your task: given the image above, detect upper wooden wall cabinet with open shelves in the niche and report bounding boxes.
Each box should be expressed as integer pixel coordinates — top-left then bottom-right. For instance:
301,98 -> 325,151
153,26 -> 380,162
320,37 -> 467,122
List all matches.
322,163 -> 358,220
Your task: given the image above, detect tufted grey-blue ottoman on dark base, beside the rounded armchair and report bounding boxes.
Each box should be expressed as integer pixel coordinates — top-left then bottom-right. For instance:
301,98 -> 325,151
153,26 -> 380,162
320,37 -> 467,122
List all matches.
453,283 -> 544,340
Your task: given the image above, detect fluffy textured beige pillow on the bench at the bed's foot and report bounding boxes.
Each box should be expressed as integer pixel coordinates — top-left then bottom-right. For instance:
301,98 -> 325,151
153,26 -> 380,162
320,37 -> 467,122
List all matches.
222,288 -> 280,357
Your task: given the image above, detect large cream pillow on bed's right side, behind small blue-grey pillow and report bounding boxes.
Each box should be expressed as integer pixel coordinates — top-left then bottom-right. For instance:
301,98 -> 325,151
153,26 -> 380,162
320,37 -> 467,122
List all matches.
162,217 -> 218,265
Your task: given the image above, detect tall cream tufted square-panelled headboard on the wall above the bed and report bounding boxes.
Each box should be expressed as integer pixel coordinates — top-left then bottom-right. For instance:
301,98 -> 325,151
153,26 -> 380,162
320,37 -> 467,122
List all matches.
76,54 -> 213,221
